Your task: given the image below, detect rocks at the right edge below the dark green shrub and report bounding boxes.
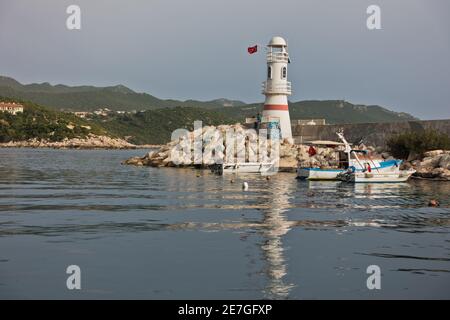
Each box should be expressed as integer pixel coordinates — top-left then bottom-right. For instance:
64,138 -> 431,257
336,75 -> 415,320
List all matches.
402,150 -> 450,181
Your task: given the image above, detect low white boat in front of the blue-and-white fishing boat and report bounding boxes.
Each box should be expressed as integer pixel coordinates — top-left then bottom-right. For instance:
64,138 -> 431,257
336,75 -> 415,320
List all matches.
338,169 -> 416,183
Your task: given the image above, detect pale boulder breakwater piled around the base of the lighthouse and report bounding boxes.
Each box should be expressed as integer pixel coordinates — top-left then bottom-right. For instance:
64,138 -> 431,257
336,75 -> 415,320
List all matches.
123,124 -> 348,172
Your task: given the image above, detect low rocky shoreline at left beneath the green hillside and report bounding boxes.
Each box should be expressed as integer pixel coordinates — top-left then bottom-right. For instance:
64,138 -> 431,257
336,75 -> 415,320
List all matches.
0,134 -> 136,149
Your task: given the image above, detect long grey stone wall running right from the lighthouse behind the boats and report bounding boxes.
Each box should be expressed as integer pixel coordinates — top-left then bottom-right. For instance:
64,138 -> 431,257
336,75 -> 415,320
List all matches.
292,119 -> 450,147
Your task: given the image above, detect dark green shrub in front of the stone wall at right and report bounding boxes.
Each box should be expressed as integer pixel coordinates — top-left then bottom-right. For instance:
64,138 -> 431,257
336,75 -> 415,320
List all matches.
386,130 -> 450,159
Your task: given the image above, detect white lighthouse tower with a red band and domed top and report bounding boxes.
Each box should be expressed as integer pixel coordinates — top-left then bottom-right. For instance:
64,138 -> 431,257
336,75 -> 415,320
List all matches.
262,37 -> 292,141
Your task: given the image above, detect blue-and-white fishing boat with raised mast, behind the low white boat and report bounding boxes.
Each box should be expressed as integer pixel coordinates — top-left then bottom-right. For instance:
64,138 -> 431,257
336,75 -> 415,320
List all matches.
297,132 -> 402,180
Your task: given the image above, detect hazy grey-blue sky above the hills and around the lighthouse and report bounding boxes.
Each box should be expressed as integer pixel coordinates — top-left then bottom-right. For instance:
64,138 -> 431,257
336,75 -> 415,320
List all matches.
0,0 -> 450,119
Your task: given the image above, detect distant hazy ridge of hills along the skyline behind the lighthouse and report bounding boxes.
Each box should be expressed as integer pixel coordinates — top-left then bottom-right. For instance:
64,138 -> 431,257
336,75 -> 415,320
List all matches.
0,76 -> 417,123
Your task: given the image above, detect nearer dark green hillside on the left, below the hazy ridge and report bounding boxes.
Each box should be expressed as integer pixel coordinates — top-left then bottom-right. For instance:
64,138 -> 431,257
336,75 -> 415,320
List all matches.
0,97 -> 236,144
